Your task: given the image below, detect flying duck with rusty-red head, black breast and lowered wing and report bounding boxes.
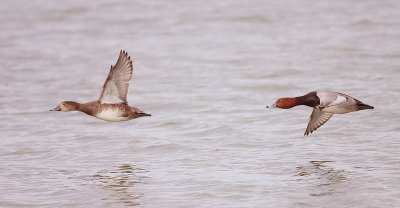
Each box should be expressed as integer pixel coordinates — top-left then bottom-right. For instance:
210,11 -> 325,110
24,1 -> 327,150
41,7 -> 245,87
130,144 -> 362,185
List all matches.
266,91 -> 374,136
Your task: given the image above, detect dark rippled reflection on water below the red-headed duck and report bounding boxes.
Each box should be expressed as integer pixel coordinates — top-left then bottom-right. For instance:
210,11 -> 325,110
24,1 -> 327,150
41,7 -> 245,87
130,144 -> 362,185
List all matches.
296,161 -> 347,196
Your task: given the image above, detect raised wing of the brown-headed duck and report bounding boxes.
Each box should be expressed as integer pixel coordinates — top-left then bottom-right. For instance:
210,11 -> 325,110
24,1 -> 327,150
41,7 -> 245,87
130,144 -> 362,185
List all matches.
99,50 -> 133,104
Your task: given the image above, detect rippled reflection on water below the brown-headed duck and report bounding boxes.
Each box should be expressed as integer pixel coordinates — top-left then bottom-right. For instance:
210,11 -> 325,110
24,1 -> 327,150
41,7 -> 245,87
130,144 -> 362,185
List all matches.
93,164 -> 146,206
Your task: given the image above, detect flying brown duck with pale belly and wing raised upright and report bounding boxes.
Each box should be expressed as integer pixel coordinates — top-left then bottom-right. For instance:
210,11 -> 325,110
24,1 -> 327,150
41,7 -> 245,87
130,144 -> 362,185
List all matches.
50,50 -> 151,122
